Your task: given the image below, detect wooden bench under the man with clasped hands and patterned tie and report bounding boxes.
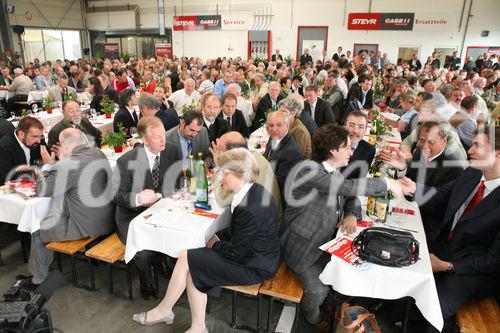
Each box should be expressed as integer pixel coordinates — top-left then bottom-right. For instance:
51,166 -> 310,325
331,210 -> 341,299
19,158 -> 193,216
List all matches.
85,233 -> 133,299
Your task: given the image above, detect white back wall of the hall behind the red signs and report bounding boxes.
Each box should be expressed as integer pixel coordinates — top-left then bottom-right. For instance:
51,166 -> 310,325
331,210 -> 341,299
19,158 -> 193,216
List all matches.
83,0 -> 500,61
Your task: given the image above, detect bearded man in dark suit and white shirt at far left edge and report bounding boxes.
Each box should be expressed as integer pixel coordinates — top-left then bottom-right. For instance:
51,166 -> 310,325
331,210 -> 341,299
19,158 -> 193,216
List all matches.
0,117 -> 48,185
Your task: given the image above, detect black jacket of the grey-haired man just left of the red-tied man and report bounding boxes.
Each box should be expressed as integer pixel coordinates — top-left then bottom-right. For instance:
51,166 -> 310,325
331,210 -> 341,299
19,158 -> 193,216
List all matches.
406,147 -> 466,243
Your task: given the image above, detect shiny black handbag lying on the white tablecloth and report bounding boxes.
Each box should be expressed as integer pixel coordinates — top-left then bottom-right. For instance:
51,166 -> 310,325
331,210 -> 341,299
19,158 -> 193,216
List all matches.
351,227 -> 419,267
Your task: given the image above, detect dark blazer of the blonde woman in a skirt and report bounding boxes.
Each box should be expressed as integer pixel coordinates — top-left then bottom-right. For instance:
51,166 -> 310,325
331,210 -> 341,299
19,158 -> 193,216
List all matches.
212,183 -> 281,272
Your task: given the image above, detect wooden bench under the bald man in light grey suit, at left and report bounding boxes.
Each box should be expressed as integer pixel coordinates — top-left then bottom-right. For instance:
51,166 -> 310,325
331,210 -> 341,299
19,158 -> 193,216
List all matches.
47,237 -> 96,290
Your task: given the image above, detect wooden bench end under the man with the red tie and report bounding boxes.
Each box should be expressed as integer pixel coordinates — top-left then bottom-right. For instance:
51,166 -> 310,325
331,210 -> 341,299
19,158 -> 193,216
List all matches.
457,297 -> 500,333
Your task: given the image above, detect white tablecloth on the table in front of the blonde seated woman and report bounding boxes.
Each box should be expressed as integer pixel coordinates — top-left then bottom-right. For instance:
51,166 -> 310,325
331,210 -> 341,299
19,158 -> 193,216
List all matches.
125,198 -> 228,262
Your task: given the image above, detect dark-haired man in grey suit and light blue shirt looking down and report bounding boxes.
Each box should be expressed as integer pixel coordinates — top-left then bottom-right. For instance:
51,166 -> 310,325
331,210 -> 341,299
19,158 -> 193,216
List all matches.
166,111 -> 213,167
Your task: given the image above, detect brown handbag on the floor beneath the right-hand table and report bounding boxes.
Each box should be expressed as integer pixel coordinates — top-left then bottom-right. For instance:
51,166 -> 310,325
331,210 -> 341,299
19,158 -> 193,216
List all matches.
335,303 -> 381,333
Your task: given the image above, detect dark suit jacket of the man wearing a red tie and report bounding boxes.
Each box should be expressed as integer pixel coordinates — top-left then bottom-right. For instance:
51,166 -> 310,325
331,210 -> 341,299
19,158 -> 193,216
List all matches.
422,168 -> 500,278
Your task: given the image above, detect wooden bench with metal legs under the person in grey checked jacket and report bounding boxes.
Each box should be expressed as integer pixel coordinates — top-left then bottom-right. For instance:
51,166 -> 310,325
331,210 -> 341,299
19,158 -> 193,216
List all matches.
259,262 -> 304,332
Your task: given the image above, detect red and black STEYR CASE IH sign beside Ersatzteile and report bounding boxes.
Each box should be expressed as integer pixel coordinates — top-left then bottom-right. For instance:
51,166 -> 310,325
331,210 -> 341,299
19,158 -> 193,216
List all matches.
347,13 -> 415,30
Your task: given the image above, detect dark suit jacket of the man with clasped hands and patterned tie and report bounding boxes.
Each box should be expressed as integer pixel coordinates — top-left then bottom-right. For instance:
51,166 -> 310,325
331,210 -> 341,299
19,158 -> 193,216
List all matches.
114,144 -> 182,244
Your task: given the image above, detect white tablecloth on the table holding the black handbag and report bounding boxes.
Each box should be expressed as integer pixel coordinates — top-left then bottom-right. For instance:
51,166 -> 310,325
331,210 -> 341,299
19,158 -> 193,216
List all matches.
319,198 -> 443,331
